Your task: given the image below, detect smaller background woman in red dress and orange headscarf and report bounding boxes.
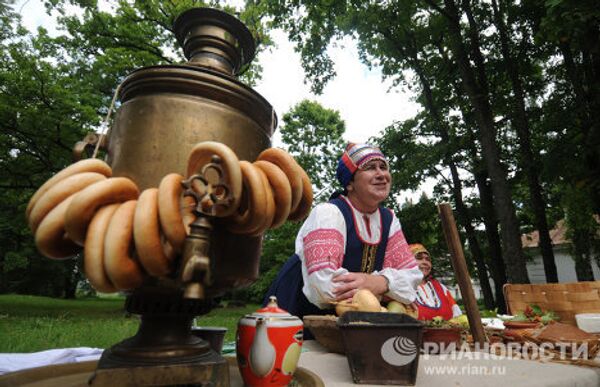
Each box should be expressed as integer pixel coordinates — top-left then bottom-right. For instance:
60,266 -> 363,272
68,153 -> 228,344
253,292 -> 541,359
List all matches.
410,243 -> 462,320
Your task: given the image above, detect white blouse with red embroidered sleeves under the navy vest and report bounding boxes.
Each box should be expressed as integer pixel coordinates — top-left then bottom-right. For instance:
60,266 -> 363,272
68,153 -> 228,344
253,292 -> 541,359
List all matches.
296,196 -> 423,309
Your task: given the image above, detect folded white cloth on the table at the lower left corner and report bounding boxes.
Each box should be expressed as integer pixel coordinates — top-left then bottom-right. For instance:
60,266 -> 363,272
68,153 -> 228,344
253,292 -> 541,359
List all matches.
0,347 -> 104,375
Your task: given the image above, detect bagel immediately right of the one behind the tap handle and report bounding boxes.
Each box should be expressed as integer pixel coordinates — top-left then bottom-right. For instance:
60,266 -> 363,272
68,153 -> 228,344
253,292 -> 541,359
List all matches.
227,161 -> 267,234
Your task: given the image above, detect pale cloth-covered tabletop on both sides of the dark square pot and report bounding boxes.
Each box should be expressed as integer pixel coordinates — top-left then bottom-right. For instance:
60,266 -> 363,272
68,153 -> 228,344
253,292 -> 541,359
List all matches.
299,340 -> 600,387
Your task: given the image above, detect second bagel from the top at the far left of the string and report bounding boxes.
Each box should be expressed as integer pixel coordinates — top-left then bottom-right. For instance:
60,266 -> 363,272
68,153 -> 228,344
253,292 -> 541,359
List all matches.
28,172 -> 106,234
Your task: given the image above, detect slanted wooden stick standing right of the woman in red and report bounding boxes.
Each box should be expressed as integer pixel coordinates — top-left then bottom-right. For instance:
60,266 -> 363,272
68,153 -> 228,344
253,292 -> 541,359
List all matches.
438,203 -> 485,345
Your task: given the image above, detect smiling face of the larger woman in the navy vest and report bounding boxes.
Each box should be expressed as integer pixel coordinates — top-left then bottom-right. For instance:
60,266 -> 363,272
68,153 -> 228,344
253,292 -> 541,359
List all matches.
348,160 -> 392,212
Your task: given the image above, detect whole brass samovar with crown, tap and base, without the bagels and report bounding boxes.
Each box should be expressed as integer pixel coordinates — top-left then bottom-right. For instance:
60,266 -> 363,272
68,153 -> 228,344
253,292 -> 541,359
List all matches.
90,8 -> 276,386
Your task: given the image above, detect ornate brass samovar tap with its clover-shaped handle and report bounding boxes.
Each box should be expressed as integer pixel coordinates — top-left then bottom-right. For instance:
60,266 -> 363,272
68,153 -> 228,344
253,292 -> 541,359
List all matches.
179,156 -> 233,299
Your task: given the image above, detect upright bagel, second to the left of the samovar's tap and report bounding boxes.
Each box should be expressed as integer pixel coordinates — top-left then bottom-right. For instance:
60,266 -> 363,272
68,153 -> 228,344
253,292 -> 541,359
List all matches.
133,188 -> 175,277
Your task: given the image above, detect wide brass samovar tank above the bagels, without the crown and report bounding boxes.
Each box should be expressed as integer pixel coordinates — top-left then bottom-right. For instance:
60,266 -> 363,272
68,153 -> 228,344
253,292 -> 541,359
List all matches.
108,66 -> 276,190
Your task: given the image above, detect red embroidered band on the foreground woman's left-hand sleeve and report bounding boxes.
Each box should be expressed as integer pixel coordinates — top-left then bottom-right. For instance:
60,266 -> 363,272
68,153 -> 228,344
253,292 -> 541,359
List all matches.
303,229 -> 344,274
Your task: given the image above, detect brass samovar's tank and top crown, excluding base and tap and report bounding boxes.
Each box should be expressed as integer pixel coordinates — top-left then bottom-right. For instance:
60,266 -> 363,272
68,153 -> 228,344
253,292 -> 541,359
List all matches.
108,9 -> 277,297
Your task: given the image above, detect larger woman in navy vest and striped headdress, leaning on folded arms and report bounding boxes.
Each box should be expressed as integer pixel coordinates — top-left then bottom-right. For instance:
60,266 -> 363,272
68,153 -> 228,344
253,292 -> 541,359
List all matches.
266,144 -> 423,318
